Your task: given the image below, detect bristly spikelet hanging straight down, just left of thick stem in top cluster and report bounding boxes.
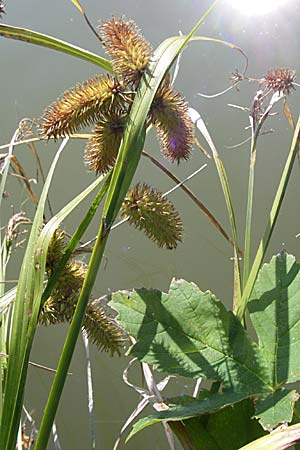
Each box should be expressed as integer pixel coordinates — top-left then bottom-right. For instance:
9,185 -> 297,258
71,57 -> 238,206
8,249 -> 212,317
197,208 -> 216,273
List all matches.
84,109 -> 126,173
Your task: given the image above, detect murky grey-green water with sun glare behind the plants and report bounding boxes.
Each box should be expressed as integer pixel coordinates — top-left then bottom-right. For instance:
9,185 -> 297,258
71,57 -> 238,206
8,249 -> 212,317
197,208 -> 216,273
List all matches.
0,0 -> 300,450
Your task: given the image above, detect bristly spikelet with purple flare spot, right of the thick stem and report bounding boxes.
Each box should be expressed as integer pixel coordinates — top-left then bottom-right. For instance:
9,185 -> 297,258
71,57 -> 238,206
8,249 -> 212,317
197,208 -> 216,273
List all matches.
150,83 -> 195,163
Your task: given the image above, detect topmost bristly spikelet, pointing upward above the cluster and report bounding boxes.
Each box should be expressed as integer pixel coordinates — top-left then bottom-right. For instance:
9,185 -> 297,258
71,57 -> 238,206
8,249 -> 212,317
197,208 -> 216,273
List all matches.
100,17 -> 152,84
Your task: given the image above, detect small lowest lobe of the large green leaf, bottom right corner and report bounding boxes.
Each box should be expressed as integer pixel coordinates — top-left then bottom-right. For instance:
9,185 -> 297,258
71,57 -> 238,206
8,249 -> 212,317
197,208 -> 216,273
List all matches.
255,388 -> 299,431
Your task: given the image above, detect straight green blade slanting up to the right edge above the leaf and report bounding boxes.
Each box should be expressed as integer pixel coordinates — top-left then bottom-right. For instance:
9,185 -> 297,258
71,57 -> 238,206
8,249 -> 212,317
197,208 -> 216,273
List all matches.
237,116 -> 300,319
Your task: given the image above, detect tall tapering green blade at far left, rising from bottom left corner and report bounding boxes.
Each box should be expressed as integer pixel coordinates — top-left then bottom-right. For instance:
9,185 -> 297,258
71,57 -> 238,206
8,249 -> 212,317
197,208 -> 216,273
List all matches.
0,138 -> 68,450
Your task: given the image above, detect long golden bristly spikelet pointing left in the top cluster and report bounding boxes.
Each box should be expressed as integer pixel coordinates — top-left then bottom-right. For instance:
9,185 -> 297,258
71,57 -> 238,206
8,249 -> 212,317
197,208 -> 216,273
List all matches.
42,75 -> 130,138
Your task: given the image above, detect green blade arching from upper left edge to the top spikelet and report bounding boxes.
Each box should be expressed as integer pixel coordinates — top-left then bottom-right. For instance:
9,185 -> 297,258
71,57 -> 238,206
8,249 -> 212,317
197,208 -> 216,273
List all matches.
0,24 -> 113,73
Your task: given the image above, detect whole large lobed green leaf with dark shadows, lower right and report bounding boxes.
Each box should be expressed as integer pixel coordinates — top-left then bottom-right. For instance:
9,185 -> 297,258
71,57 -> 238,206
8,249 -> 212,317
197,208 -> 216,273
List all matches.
111,253 -> 300,442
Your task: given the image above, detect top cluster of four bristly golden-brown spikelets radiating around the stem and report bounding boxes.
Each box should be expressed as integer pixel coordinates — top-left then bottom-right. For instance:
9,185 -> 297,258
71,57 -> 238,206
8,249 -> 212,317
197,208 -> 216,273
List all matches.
42,18 -> 194,173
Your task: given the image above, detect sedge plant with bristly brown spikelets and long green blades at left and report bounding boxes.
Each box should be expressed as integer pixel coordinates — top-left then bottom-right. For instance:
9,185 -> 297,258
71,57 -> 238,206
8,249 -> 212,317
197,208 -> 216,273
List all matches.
0,2 -> 247,450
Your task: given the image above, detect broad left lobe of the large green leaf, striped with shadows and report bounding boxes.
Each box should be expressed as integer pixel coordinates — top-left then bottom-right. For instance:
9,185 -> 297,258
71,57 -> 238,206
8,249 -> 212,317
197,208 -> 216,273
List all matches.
111,280 -> 272,395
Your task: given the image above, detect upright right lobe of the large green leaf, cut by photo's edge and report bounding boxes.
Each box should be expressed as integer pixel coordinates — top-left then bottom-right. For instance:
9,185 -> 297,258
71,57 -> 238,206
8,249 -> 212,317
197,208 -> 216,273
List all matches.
248,254 -> 300,389
